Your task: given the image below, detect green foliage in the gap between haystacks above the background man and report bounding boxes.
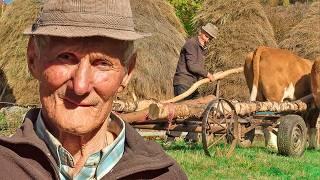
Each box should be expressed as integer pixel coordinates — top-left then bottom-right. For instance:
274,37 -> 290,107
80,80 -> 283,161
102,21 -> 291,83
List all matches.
167,0 -> 203,35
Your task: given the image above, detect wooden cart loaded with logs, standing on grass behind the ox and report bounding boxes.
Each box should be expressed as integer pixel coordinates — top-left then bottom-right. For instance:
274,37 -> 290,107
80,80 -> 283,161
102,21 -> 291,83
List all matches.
126,83 -> 320,156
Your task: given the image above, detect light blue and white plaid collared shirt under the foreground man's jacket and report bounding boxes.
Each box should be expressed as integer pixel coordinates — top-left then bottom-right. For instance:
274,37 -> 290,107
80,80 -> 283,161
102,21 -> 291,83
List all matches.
36,111 -> 125,180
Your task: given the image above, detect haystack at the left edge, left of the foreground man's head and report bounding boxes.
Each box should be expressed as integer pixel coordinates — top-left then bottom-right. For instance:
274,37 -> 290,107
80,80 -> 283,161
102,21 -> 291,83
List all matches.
0,0 -> 39,104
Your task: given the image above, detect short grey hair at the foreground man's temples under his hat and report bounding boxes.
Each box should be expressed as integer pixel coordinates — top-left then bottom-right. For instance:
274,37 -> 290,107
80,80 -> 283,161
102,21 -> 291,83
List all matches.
33,36 -> 136,69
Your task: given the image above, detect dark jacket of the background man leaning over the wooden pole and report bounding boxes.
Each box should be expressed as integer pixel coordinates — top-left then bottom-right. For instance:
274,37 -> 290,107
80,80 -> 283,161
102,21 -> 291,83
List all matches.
173,36 -> 208,87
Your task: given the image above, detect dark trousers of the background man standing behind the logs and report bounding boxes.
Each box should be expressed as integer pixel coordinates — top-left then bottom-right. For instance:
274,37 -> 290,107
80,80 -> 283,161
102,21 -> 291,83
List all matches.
166,84 -> 200,142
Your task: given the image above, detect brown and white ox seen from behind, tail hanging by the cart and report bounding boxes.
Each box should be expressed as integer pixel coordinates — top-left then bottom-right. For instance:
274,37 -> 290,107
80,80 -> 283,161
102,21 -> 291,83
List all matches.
244,46 -> 312,148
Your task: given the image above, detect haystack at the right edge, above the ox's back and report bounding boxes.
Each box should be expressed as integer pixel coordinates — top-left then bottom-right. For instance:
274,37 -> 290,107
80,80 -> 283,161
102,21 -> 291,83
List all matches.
279,1 -> 320,60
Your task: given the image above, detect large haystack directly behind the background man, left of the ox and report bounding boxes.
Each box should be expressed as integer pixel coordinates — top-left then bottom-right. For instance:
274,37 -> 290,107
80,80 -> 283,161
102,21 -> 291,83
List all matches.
196,0 -> 277,100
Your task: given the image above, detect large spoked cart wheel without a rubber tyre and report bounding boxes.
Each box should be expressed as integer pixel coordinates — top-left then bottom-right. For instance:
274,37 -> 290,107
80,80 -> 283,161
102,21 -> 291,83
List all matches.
202,99 -> 238,156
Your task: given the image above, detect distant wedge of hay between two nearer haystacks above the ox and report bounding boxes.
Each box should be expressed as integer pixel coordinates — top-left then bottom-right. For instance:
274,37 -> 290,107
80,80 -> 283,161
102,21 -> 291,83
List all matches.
264,3 -> 309,43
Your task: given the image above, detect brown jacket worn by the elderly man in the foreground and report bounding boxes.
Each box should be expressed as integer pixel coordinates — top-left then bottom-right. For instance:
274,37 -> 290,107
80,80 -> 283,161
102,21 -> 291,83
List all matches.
0,109 -> 187,180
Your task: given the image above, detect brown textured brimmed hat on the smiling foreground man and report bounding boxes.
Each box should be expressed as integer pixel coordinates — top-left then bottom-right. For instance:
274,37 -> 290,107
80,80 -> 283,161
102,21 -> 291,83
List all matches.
24,0 -> 150,41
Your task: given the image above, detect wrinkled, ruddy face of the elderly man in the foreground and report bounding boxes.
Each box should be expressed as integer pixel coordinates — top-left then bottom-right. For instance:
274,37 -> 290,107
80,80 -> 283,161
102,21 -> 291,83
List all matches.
28,37 -> 135,135
